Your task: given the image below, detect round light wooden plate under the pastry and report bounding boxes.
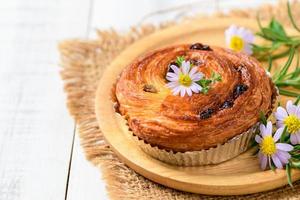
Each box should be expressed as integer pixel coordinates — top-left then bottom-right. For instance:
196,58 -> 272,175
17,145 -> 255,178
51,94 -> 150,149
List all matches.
96,18 -> 300,195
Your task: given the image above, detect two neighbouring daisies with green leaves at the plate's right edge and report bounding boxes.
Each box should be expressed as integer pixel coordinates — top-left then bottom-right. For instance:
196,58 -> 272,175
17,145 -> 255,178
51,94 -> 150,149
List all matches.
255,96 -> 300,186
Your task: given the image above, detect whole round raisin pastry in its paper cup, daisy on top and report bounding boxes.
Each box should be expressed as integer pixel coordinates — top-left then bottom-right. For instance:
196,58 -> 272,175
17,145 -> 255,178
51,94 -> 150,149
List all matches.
115,43 -> 276,166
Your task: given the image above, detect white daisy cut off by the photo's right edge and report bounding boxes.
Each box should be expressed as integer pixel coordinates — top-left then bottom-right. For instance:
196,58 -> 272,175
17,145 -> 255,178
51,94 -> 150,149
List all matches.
275,101 -> 300,145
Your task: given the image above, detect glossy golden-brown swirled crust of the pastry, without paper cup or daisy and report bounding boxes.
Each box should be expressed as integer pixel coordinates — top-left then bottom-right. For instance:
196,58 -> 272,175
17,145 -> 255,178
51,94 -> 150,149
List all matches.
116,45 -> 274,152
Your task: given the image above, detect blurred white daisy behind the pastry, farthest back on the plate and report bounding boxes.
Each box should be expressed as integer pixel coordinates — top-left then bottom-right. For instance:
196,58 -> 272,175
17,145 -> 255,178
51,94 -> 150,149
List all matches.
225,25 -> 254,55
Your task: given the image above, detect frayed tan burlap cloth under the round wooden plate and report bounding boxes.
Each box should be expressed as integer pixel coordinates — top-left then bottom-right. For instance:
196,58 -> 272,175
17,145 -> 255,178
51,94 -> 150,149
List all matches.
59,2 -> 300,199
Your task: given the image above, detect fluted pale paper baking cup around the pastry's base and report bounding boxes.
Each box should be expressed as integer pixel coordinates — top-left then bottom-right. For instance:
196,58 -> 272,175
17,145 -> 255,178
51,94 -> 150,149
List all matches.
129,124 -> 258,166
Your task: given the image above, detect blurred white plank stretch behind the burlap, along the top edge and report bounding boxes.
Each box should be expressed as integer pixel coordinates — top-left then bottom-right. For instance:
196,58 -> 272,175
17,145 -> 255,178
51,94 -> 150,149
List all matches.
91,0 -> 217,30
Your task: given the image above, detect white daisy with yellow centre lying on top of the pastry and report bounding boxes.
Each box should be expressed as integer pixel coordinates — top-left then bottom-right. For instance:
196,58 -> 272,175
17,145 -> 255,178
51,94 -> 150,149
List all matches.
166,61 -> 204,97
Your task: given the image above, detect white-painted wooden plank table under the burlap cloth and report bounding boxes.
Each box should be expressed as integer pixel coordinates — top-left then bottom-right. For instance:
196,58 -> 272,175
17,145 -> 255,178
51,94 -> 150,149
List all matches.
0,0 -> 276,200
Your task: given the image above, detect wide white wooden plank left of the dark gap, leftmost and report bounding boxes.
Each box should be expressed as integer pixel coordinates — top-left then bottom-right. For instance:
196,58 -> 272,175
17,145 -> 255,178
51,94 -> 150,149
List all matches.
0,0 -> 89,200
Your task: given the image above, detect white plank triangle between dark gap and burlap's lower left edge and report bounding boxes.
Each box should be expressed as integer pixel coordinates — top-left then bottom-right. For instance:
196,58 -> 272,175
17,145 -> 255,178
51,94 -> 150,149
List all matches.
67,135 -> 108,200
